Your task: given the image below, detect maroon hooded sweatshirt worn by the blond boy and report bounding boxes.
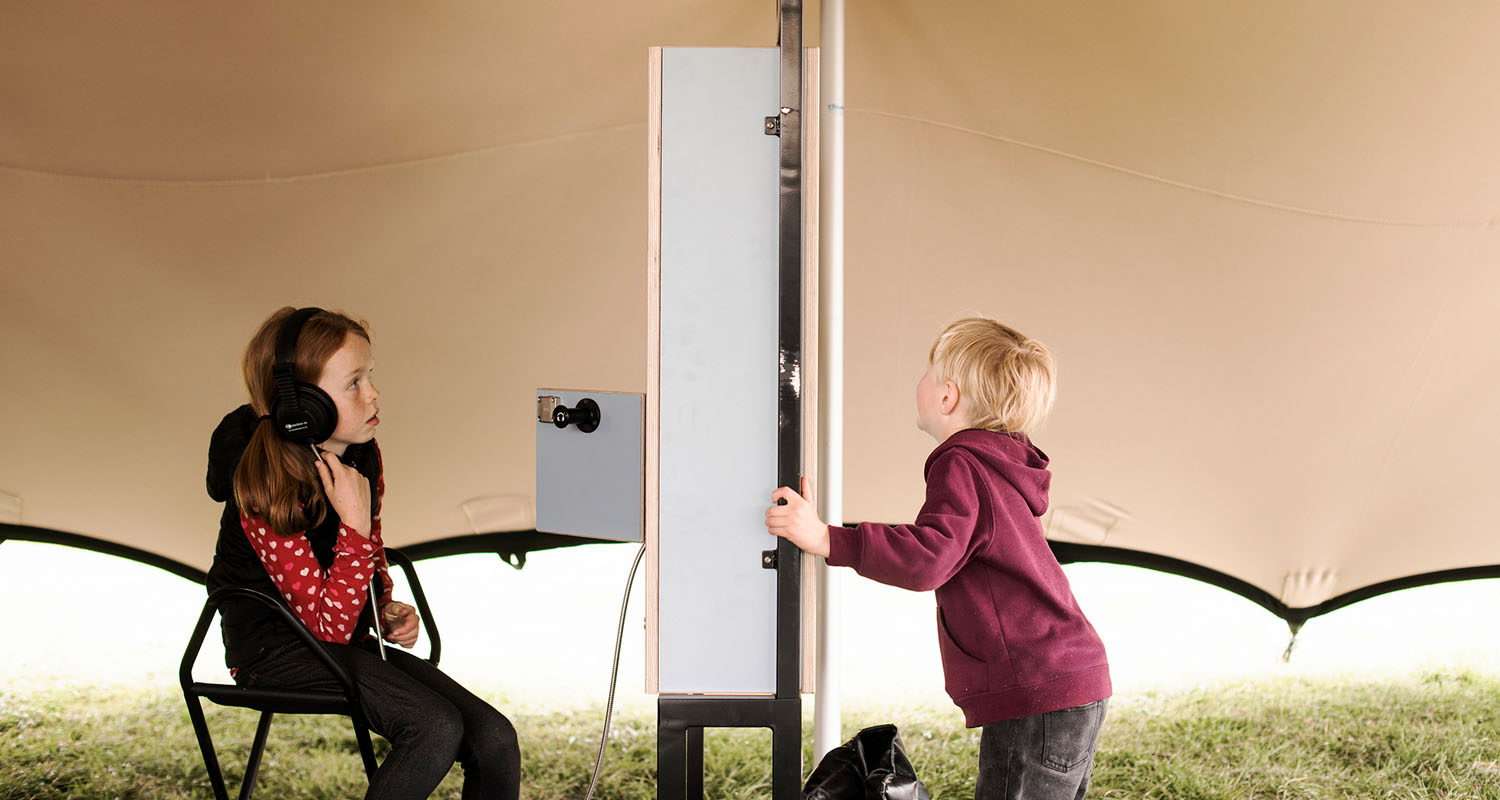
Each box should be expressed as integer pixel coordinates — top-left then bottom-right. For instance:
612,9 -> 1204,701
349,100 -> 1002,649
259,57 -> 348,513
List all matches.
828,429 -> 1110,728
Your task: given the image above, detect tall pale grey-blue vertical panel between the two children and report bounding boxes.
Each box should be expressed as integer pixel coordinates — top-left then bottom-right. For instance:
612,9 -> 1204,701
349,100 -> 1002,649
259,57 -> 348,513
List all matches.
657,48 -> 780,693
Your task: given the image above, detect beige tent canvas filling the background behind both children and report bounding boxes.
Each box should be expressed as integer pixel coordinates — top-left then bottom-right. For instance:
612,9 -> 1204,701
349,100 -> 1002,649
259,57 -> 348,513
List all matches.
0,0 -> 1500,633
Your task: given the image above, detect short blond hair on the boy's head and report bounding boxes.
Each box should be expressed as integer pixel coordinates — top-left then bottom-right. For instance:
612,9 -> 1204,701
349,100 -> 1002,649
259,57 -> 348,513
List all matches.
927,317 -> 1058,434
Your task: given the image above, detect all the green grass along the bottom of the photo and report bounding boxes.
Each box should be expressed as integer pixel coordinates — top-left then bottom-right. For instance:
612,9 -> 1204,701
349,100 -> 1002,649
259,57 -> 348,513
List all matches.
0,671 -> 1500,800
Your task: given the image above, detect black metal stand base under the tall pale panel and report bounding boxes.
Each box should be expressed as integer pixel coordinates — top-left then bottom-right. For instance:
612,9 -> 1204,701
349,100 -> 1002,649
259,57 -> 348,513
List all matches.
657,696 -> 803,800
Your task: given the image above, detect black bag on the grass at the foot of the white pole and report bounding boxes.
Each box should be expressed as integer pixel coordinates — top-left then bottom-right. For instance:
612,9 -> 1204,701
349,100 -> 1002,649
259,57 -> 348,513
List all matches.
803,725 -> 930,800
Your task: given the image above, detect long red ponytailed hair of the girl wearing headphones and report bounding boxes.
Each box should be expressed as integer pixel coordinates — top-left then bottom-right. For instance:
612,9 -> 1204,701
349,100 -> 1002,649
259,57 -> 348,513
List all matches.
234,306 -> 371,536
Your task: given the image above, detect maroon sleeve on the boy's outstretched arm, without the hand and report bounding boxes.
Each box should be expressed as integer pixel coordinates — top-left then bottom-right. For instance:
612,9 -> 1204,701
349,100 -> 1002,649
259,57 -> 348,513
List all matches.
828,453 -> 981,591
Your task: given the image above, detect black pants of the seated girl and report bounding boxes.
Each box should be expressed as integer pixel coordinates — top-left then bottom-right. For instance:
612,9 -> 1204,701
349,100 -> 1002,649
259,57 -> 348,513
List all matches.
239,642 -> 521,800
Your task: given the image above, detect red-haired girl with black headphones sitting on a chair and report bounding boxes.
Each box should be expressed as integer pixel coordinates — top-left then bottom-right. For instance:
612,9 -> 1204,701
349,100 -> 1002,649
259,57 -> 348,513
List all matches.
209,308 -> 521,800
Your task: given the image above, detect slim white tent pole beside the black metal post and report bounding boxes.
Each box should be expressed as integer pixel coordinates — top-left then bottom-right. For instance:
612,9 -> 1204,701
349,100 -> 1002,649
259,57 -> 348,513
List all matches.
813,0 -> 845,764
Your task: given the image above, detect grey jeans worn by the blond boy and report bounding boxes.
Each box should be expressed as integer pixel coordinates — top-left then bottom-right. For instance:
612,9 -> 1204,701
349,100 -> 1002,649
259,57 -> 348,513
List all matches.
974,699 -> 1109,800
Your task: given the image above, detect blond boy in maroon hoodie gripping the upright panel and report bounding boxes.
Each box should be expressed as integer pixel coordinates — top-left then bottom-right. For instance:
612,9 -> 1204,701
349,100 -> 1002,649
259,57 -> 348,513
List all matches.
765,317 -> 1110,800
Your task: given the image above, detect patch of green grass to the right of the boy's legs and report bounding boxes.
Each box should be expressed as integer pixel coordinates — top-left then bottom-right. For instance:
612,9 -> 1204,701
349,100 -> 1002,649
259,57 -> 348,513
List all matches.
1092,671 -> 1500,800
